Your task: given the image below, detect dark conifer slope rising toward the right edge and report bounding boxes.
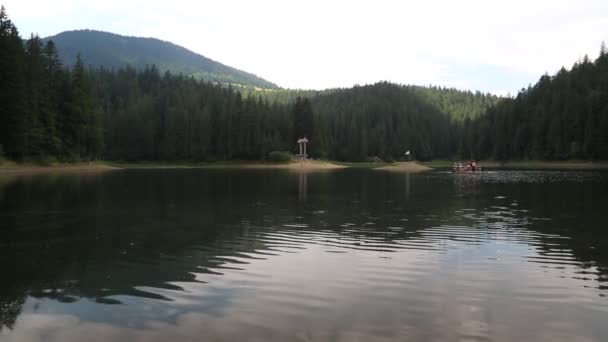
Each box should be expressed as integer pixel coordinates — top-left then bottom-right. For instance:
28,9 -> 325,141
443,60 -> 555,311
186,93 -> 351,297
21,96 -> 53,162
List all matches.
463,44 -> 608,160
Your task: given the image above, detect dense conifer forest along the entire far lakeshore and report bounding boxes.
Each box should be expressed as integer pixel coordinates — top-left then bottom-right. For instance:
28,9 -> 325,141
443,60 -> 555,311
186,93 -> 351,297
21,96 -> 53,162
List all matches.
0,9 -> 608,162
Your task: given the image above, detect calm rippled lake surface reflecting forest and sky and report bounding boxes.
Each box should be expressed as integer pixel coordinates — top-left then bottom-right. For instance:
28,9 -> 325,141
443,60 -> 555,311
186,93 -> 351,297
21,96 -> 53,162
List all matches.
0,169 -> 608,342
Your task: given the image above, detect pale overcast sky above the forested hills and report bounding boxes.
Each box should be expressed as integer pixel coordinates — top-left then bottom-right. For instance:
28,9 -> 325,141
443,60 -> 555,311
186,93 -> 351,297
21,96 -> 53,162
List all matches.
0,0 -> 608,95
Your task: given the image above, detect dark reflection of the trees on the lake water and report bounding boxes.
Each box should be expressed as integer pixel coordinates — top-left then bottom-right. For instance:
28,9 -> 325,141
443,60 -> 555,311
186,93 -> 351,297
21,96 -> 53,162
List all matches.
0,170 -> 608,327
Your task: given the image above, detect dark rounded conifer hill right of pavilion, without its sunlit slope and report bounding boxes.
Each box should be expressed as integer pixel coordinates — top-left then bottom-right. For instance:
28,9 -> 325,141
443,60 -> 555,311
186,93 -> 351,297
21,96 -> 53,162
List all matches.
312,82 -> 452,161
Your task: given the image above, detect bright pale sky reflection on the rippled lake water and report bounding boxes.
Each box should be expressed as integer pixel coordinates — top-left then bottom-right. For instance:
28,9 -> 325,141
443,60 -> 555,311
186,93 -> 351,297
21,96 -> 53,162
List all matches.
5,218 -> 608,341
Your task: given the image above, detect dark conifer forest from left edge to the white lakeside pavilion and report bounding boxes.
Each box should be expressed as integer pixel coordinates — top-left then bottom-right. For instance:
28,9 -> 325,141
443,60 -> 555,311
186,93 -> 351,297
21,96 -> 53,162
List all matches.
0,8 -> 295,161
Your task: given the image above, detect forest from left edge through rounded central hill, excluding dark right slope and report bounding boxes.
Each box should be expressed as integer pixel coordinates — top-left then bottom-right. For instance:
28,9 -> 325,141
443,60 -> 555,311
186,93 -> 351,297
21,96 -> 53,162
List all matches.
0,7 -> 486,161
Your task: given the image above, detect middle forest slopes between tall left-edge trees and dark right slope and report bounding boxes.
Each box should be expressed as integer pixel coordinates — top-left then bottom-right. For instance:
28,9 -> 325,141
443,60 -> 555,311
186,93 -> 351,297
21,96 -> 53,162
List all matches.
91,79 -> 484,161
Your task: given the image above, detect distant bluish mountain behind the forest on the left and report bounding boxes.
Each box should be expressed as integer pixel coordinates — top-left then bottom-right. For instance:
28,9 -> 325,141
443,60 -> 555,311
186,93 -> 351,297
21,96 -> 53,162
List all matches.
45,30 -> 278,89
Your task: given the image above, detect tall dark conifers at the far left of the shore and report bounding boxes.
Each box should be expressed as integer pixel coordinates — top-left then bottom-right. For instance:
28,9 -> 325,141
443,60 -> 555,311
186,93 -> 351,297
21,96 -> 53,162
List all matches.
0,8 -> 102,161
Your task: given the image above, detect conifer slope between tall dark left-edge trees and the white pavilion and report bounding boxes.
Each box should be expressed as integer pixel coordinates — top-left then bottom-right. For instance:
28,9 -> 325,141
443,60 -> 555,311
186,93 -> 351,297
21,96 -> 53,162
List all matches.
92,67 -> 295,161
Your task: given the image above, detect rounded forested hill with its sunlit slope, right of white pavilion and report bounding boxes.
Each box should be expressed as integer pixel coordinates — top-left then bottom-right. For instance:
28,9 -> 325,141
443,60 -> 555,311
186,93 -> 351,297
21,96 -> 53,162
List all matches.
311,82 -> 501,160
